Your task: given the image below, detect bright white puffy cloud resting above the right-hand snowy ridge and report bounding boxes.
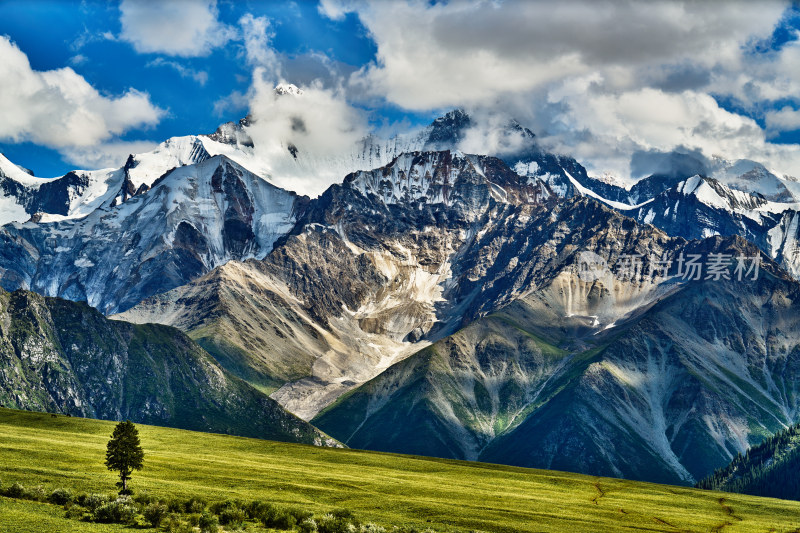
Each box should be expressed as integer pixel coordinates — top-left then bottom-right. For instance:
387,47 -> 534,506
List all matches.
538,79 -> 780,177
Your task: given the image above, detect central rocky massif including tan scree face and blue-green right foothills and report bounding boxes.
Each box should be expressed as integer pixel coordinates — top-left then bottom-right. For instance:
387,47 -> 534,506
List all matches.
118,147 -> 800,483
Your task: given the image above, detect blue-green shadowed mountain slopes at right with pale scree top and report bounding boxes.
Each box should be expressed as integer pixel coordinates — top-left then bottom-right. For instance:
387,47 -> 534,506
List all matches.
313,237 -> 800,483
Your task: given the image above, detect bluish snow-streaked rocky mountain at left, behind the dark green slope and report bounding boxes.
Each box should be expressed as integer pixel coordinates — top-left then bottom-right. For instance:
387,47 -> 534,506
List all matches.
0,156 -> 307,313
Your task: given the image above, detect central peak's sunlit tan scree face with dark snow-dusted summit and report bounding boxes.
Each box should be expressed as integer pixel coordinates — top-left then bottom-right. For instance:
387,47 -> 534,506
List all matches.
120,151 -> 555,418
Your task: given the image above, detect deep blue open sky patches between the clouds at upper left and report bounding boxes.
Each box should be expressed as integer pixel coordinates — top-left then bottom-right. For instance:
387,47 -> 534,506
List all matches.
0,1 -> 393,177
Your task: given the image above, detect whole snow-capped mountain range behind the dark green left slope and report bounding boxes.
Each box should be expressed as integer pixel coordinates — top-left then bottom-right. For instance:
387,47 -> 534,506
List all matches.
0,88 -> 800,484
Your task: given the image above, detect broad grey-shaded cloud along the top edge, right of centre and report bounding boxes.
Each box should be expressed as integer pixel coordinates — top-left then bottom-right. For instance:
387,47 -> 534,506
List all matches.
330,1 -> 783,110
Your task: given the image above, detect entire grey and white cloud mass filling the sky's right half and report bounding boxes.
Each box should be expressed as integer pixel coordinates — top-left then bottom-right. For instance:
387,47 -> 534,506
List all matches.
319,0 -> 800,177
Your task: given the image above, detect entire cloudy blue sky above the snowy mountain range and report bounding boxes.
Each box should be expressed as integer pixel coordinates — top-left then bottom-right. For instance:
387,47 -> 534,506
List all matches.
0,0 -> 800,182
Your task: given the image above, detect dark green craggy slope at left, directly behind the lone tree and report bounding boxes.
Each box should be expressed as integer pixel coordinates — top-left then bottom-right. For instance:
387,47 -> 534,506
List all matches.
0,289 -> 337,445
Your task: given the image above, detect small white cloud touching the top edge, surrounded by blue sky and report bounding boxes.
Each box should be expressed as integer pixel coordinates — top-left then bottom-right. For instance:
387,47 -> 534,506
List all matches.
119,0 -> 236,57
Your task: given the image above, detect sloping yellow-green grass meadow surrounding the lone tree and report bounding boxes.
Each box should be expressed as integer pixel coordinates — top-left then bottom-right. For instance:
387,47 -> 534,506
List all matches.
0,409 -> 800,533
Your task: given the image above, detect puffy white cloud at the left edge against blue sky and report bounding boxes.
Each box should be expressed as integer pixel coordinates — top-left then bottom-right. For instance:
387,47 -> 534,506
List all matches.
0,36 -> 164,149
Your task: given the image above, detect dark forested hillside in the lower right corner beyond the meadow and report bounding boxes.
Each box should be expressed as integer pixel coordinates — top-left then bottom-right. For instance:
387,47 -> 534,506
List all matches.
695,424 -> 800,500
